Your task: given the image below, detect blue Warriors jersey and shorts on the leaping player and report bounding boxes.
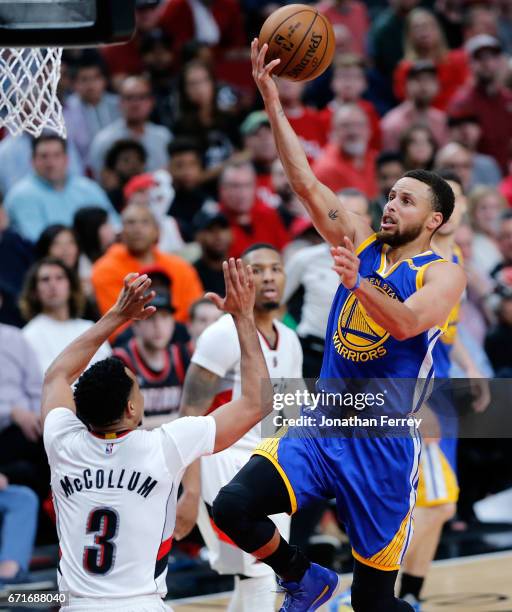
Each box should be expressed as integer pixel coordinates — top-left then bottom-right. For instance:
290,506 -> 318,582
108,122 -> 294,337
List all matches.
255,234 -> 444,570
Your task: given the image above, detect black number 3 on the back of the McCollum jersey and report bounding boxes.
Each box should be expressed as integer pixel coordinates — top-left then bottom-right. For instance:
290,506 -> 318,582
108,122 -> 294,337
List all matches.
84,507 -> 119,574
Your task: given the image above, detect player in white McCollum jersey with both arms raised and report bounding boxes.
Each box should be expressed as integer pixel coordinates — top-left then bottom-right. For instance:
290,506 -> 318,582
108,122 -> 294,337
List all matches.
42,259 -> 272,612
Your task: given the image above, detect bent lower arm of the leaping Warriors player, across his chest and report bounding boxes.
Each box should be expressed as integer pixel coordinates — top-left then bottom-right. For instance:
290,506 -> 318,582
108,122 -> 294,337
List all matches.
331,238 -> 466,340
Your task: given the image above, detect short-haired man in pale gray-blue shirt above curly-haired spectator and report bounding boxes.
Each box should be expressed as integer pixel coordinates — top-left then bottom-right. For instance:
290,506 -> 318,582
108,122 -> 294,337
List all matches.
89,76 -> 172,180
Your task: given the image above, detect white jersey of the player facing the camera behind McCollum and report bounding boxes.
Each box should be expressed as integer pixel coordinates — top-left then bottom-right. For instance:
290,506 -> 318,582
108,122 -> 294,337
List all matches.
192,315 -> 302,452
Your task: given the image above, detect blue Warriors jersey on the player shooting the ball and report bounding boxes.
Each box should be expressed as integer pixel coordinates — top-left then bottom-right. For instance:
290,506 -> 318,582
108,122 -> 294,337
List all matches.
317,234 -> 445,414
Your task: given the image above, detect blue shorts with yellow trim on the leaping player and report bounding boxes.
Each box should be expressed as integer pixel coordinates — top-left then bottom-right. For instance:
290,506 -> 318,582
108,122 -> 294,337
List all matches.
254,427 -> 420,571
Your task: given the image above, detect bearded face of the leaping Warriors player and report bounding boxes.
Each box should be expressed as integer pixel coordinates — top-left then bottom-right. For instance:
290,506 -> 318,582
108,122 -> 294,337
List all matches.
378,178 -> 442,247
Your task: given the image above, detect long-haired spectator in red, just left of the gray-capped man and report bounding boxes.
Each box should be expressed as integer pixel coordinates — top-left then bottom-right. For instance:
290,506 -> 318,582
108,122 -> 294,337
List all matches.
394,8 -> 469,110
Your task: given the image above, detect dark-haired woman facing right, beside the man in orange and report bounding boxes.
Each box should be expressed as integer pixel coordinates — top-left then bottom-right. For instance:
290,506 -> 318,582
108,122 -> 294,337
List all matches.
73,206 -> 116,298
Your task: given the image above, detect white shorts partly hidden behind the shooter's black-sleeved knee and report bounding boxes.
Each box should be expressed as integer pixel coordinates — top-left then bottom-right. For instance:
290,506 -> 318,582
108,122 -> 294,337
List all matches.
197,447 -> 291,578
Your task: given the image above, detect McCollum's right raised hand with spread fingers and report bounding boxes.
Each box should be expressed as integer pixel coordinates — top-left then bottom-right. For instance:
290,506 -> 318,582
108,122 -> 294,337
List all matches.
205,257 -> 256,317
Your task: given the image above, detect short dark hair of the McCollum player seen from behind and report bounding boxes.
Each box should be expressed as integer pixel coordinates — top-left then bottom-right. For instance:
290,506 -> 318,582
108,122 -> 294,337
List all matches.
74,357 -> 133,427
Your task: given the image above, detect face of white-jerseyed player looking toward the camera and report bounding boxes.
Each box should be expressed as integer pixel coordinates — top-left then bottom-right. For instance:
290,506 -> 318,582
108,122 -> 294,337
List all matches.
244,249 -> 285,310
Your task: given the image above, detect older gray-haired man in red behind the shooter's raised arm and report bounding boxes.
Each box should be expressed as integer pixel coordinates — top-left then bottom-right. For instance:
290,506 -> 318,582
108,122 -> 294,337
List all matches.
313,104 -> 378,198
